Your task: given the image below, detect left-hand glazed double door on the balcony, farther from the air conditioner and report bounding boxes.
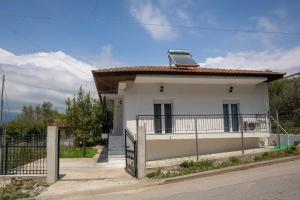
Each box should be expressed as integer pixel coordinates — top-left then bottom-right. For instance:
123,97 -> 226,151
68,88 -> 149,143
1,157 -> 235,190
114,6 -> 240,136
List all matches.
154,103 -> 172,133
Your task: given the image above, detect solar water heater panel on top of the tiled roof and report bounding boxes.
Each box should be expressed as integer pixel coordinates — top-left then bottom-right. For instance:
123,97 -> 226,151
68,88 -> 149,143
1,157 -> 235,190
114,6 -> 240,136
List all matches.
168,50 -> 199,67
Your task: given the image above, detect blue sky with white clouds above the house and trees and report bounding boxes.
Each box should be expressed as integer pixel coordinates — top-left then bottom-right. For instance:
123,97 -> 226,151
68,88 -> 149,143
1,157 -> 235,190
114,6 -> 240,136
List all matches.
0,0 -> 300,120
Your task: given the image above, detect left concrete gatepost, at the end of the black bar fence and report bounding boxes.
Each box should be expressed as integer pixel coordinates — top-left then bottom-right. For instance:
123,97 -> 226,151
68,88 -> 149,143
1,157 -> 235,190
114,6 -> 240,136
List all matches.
47,126 -> 59,184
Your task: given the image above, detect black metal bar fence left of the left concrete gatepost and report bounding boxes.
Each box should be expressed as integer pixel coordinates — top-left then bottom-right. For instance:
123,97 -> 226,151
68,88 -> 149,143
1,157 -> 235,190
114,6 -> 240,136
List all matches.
0,128 -> 47,175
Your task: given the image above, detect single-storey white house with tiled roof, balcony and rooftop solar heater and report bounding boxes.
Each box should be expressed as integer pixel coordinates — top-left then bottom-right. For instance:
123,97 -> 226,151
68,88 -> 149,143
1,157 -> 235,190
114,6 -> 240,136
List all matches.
93,51 -> 284,166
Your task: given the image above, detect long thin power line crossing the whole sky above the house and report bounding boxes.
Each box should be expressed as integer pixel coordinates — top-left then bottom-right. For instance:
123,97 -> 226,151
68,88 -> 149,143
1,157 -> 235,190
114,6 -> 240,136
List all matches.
0,12 -> 300,36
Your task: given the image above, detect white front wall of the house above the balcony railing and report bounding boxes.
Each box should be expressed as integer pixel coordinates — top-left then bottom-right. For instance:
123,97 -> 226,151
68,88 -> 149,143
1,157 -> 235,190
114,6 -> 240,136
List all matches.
123,82 -> 269,134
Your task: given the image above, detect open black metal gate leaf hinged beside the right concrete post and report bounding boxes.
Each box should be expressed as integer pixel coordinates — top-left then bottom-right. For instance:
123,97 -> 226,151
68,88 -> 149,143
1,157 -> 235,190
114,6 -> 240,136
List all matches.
125,129 -> 137,177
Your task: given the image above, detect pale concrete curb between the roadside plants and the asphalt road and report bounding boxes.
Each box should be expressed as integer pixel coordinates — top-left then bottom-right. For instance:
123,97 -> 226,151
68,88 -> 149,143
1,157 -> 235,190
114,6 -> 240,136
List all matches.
159,155 -> 300,185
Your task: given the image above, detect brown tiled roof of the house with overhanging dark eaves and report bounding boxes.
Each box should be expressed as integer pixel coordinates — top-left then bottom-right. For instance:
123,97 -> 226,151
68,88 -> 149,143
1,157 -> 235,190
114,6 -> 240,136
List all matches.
92,66 -> 284,91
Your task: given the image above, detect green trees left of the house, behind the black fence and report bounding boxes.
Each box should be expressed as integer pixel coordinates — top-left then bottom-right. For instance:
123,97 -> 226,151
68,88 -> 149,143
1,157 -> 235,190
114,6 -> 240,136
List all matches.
6,87 -> 113,153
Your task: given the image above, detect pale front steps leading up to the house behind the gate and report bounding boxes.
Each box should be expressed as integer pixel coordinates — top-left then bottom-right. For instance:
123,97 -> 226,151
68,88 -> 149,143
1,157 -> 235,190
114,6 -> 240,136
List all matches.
107,135 -> 125,167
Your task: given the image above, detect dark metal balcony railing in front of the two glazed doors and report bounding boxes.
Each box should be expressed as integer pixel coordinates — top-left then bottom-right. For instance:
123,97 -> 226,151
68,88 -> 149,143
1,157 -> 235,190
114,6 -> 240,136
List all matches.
137,114 -> 269,134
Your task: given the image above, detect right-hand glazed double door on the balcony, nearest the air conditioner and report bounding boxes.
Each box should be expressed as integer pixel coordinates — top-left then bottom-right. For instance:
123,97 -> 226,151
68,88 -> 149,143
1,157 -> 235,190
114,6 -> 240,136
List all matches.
223,103 -> 239,132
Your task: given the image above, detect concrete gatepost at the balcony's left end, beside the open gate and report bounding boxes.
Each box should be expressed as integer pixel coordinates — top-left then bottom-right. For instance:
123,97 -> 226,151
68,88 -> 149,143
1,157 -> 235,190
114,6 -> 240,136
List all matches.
137,126 -> 146,178
